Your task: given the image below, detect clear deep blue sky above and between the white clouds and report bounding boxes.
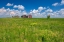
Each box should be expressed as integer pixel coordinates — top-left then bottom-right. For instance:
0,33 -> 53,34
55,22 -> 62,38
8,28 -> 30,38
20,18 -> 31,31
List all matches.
0,0 -> 63,11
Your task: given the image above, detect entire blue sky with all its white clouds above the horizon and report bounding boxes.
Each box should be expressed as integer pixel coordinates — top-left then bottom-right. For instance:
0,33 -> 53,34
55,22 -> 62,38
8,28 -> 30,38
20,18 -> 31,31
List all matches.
0,0 -> 64,18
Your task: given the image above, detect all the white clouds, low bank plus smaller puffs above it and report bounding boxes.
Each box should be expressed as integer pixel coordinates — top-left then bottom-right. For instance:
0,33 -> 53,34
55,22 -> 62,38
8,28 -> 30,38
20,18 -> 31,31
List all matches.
0,0 -> 64,18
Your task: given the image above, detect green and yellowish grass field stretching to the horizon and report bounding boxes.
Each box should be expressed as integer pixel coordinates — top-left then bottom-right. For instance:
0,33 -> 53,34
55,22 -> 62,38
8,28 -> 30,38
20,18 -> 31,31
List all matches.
0,18 -> 64,42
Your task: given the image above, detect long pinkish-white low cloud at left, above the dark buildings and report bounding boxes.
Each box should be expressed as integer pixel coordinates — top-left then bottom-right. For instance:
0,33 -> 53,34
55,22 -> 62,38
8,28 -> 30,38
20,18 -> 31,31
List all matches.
0,8 -> 26,17
